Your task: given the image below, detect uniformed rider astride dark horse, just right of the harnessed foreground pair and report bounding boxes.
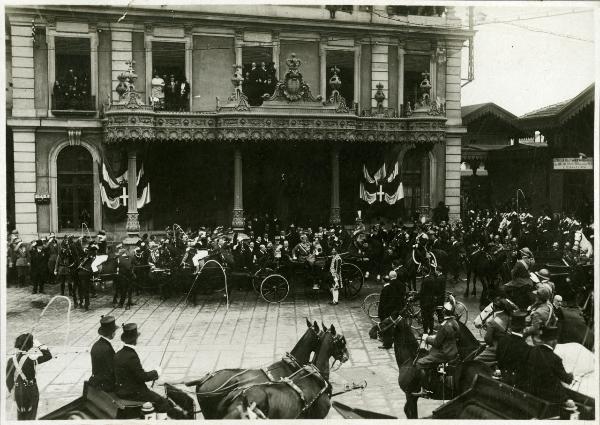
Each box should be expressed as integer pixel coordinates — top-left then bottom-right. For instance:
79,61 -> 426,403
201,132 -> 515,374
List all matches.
413,301 -> 460,397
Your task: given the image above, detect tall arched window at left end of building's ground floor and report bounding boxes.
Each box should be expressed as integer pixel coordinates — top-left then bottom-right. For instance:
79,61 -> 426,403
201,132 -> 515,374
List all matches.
57,146 -> 94,231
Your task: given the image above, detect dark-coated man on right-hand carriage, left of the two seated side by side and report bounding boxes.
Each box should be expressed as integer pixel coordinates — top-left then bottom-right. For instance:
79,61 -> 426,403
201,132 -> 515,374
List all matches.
496,311 -> 531,389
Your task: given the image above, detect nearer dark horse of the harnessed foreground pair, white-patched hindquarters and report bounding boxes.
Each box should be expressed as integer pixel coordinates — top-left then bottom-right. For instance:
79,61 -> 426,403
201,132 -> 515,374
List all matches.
223,325 -> 348,419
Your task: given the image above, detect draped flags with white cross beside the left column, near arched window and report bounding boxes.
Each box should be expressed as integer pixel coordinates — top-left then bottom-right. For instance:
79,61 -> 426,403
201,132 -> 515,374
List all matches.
100,162 -> 151,210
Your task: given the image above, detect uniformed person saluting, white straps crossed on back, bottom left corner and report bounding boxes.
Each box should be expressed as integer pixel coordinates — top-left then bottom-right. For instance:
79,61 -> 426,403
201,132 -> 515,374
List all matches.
6,333 -> 52,421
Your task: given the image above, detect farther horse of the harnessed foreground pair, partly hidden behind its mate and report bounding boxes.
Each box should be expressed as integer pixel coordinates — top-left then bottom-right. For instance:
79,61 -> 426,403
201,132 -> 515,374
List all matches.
186,319 -> 323,419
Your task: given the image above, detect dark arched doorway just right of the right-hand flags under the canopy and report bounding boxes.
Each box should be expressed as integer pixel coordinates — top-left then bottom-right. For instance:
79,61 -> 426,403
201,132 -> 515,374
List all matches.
401,148 -> 430,220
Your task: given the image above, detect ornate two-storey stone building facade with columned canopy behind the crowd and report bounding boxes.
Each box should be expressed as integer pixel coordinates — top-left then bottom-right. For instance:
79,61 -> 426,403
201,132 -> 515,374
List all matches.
6,5 -> 472,238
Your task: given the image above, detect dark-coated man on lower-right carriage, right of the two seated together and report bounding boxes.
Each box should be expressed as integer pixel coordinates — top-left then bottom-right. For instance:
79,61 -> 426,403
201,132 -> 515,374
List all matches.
526,326 -> 573,403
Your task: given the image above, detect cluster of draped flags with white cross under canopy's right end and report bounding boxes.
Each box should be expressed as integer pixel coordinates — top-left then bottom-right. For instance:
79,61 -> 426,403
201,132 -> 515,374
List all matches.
359,161 -> 404,205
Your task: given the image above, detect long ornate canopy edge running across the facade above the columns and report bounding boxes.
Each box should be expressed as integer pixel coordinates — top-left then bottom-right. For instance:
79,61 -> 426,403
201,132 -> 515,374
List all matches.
104,108 -> 446,144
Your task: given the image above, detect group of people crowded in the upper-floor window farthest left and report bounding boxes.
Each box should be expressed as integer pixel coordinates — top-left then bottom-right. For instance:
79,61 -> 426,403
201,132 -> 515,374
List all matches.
52,68 -> 92,110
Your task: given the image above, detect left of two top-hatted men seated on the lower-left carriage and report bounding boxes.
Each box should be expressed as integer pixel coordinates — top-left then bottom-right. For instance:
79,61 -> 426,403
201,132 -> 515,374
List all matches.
89,316 -> 117,391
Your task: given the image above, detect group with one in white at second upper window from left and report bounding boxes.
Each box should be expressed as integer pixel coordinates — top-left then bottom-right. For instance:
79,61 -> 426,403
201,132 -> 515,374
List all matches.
150,70 -> 190,112
